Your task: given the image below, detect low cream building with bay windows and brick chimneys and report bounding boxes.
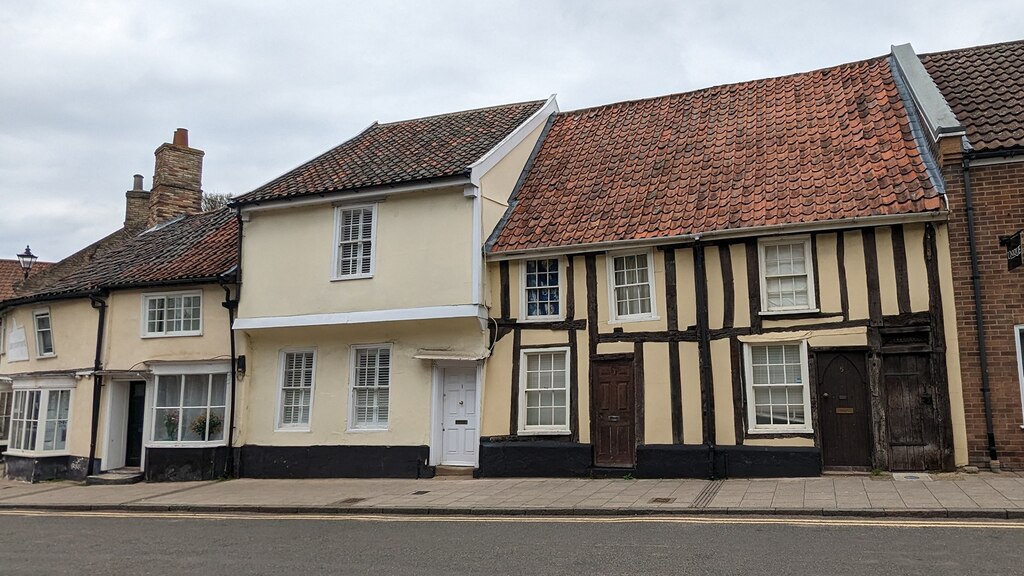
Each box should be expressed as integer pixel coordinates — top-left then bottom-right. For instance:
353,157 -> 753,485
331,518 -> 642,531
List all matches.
0,130 -> 238,481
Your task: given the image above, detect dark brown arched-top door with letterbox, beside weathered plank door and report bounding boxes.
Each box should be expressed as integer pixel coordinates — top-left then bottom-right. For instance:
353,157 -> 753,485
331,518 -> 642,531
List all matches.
814,352 -> 871,467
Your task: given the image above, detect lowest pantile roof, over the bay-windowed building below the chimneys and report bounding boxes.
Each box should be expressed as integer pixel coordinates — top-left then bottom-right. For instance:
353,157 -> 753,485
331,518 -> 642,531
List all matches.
9,208 -> 238,298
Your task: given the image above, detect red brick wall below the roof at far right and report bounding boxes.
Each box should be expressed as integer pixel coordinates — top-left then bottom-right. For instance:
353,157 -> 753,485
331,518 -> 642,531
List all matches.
943,155 -> 1024,469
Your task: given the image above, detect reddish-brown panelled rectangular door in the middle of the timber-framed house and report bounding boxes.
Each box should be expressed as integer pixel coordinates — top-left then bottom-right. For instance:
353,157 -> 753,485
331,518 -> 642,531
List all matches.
591,361 -> 637,468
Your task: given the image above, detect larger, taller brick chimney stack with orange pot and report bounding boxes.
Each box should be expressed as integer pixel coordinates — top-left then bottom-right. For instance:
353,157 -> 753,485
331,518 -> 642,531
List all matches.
146,128 -> 205,227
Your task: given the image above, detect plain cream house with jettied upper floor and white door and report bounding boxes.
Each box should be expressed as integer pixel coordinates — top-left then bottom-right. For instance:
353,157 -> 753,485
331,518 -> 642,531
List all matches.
233,96 -> 557,478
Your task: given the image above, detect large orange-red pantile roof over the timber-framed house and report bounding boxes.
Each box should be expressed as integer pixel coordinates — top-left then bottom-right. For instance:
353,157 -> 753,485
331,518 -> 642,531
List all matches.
489,57 -> 942,252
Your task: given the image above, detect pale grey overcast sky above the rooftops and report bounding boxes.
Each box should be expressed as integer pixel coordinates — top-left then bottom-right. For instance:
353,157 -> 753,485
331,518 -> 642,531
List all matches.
0,0 -> 1024,260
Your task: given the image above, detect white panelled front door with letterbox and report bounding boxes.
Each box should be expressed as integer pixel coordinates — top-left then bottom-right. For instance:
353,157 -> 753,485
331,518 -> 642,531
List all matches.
441,366 -> 480,466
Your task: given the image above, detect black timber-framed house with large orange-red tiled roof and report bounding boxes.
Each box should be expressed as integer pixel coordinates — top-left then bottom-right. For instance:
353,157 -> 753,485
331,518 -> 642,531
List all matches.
478,45 -> 968,477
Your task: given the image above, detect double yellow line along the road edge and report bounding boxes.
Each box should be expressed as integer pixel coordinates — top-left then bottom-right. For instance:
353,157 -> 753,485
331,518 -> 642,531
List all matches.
0,510 -> 1024,530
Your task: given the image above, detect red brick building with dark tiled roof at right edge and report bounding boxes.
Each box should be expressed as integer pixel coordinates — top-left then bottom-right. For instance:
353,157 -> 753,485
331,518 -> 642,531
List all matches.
911,41 -> 1024,469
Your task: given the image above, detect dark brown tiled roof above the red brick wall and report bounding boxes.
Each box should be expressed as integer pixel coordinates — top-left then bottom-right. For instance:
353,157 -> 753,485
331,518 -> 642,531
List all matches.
921,40 -> 1024,151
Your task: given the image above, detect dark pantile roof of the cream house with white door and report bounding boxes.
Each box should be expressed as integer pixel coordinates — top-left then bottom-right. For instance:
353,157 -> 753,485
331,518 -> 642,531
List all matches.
234,100 -> 545,204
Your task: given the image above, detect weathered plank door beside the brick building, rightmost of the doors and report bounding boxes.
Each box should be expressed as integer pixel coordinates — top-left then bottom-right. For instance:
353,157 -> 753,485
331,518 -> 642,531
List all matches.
882,354 -> 948,470
